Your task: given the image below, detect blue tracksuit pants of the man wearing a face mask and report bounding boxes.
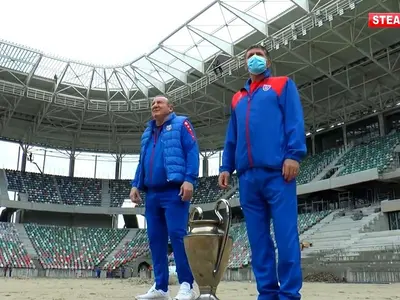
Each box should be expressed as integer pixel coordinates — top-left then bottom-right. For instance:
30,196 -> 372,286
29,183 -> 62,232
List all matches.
239,169 -> 302,300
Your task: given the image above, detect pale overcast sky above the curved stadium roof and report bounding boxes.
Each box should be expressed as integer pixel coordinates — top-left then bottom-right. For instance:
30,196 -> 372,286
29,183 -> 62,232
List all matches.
0,0 -> 216,65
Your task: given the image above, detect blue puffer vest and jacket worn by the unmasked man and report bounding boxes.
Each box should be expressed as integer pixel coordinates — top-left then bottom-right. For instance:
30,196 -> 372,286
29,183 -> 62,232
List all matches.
132,113 -> 200,191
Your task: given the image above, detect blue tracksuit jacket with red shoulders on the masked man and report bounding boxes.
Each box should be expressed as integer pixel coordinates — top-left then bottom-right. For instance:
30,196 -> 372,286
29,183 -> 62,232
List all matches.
220,70 -> 307,175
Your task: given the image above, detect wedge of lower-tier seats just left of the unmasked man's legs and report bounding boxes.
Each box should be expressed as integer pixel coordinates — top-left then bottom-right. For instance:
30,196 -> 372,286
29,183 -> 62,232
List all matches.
104,229 -> 149,269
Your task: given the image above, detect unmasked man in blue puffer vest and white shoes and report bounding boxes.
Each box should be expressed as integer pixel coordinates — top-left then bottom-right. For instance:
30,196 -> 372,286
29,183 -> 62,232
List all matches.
130,96 -> 200,300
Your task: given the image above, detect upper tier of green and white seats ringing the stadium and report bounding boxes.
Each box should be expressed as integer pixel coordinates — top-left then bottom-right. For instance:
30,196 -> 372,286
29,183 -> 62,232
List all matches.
6,132 -> 400,207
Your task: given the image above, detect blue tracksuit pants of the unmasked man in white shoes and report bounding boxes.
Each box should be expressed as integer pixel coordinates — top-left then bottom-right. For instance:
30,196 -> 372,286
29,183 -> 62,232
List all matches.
145,187 -> 193,292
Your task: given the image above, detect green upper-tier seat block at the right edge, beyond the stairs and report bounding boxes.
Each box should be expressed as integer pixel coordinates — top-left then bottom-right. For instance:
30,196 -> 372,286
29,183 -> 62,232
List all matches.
337,132 -> 400,176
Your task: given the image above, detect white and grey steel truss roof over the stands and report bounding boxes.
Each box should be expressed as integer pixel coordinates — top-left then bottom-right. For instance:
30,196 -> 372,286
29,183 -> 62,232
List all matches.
0,0 -> 400,153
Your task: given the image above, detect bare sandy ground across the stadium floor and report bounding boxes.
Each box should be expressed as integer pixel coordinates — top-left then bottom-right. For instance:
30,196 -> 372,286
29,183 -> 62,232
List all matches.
0,278 -> 400,300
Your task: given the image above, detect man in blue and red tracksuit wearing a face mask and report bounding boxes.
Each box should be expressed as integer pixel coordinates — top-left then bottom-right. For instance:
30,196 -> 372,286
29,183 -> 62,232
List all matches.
219,45 -> 307,300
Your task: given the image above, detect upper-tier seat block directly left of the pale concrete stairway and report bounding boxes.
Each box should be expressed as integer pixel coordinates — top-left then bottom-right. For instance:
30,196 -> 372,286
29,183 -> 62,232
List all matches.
55,176 -> 101,206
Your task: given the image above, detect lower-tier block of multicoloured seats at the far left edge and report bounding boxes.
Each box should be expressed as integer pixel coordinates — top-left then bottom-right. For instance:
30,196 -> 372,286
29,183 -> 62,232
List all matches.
0,222 -> 35,269
